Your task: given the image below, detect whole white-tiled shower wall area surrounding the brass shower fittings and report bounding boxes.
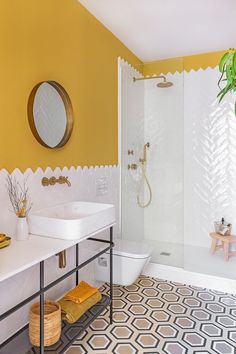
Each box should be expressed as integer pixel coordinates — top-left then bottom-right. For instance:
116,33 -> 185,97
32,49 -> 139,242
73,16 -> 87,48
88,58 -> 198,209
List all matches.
121,59 -> 236,277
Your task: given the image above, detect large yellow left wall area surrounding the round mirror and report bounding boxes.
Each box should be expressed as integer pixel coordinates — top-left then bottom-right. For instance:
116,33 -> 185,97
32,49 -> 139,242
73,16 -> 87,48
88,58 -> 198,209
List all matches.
0,0 -> 141,171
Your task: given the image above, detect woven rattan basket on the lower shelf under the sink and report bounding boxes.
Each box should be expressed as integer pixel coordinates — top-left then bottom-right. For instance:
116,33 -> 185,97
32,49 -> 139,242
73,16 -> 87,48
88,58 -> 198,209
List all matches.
29,301 -> 61,347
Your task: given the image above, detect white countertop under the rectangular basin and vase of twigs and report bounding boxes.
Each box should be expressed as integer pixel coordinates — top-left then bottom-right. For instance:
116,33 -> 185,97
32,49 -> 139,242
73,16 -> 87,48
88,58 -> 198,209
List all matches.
0,224 -> 114,282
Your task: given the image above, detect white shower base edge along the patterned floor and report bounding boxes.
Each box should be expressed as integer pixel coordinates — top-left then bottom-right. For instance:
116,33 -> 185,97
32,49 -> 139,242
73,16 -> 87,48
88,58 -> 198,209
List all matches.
142,263 -> 236,294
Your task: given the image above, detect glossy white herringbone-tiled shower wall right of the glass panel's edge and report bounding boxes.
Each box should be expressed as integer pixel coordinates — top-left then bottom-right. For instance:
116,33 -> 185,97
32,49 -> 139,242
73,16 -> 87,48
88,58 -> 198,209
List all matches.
184,67 -> 236,247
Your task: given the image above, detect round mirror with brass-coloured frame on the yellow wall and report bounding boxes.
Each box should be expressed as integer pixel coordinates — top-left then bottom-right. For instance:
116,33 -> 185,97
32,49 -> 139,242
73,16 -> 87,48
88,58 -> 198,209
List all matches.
28,81 -> 73,149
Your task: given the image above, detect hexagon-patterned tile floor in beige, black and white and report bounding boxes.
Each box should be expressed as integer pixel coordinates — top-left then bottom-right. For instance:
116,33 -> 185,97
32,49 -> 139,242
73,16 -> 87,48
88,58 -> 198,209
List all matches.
66,276 -> 236,354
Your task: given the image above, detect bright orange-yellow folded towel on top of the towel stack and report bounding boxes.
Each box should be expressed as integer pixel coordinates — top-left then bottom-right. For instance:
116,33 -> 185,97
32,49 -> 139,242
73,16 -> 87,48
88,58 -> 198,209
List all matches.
64,280 -> 98,304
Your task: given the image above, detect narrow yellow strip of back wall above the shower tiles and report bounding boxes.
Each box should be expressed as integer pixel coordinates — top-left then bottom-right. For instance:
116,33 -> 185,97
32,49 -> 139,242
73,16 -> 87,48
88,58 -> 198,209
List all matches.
143,51 -> 225,76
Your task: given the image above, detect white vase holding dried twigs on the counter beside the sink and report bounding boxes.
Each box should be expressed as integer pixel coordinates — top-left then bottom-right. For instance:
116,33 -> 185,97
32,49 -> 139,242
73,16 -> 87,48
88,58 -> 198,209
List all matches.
7,175 -> 32,241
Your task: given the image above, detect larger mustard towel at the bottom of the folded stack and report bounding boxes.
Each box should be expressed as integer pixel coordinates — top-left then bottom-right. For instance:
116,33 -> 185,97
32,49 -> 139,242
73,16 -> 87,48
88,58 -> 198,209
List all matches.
58,290 -> 102,324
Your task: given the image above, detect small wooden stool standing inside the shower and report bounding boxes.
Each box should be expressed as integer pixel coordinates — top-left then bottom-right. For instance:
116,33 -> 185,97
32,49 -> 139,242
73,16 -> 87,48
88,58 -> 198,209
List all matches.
210,232 -> 236,261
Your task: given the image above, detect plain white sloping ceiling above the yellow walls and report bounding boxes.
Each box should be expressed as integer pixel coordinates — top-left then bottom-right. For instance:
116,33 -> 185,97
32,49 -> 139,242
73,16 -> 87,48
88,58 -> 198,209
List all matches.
79,0 -> 236,61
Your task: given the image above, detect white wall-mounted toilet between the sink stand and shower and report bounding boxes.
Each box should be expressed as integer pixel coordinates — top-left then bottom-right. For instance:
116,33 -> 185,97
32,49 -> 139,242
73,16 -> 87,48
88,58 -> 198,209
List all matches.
95,239 -> 151,286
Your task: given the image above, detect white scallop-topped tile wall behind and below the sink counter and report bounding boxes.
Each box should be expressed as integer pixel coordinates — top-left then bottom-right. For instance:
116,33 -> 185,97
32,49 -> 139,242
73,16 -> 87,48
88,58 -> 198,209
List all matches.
0,166 -> 119,343
